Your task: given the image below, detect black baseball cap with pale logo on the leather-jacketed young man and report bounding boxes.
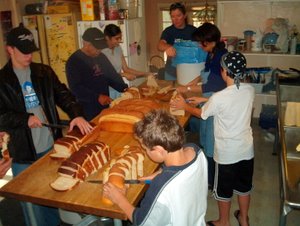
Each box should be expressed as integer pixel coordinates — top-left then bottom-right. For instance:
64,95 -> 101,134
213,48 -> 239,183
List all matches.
6,23 -> 39,54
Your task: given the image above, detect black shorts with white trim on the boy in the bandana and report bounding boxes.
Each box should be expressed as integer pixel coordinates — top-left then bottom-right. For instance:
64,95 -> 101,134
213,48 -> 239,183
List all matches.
213,159 -> 254,201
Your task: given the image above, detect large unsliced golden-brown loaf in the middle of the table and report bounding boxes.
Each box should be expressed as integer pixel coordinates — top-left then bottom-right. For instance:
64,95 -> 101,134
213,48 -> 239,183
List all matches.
99,99 -> 160,133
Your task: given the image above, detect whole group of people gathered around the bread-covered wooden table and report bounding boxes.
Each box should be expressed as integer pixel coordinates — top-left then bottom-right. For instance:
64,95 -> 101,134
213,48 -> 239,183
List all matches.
0,3 -> 254,226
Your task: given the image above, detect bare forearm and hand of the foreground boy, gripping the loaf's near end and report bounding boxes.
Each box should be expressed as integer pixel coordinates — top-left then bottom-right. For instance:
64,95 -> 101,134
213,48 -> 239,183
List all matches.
103,183 -> 135,222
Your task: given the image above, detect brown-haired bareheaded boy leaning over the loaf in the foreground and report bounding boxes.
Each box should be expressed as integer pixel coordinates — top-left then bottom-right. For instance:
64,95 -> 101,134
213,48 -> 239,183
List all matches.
103,110 -> 208,226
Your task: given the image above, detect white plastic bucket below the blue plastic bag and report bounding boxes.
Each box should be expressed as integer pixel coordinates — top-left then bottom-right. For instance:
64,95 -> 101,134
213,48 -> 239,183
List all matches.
176,63 -> 205,85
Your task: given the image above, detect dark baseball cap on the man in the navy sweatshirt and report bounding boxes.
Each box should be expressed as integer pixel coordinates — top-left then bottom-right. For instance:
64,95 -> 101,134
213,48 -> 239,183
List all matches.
82,27 -> 107,49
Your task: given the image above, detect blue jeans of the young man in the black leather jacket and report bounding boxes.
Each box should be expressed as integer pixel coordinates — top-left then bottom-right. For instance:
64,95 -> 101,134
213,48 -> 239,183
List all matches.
12,152 -> 60,226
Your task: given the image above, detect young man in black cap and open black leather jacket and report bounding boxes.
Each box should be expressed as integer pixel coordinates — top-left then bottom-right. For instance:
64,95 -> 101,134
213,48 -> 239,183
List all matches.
0,24 -> 92,226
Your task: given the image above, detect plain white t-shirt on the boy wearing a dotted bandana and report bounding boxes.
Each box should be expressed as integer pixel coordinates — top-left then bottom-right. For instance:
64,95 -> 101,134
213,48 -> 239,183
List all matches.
201,83 -> 255,164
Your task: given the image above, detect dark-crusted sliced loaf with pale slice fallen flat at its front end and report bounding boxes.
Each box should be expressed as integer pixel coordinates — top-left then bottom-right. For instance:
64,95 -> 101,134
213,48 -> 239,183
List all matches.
50,142 -> 111,191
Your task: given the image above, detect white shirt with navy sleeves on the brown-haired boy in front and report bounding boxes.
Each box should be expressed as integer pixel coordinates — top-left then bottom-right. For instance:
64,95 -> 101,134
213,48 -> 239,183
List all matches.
133,144 -> 208,226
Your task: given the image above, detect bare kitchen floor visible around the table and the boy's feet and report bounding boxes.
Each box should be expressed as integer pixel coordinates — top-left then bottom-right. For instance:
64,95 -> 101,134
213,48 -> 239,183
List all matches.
0,120 -> 300,226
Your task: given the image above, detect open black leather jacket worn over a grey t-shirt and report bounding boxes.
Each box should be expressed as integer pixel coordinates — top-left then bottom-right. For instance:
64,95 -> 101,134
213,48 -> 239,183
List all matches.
0,61 -> 83,163
